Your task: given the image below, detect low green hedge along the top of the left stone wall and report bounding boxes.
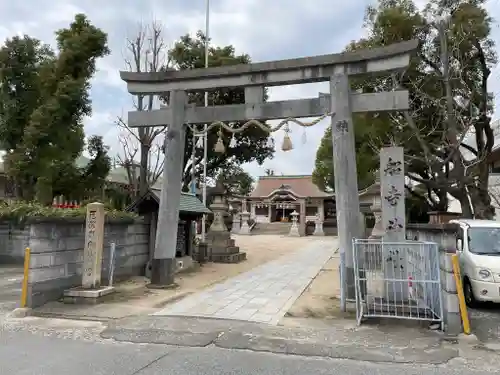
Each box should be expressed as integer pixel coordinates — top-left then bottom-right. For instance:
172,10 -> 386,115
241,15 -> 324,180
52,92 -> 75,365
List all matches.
0,201 -> 137,225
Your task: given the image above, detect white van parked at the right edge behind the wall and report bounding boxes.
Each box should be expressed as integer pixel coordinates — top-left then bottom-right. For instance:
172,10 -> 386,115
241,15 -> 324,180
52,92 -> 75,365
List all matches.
450,219 -> 500,307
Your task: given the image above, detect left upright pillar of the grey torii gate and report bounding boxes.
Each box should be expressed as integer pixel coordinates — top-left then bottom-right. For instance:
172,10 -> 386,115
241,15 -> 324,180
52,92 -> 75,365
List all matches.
150,91 -> 186,288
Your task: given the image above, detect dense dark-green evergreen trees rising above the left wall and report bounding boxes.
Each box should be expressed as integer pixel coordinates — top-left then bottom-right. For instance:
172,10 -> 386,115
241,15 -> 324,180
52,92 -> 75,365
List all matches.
0,14 -> 109,204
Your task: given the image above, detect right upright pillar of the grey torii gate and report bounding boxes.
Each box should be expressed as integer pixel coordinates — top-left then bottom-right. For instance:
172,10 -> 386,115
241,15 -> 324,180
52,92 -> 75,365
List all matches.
330,74 -> 360,299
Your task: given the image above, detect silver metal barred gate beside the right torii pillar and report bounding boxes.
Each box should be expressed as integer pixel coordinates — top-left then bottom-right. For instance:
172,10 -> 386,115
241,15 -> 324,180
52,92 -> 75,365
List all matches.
353,239 -> 443,324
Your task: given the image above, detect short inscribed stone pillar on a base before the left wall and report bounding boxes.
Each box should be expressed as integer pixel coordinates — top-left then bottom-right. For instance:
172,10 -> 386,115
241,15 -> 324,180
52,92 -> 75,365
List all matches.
63,202 -> 114,304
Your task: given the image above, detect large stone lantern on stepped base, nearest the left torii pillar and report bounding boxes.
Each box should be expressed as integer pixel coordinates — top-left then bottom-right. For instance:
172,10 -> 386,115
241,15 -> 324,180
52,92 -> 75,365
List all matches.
207,183 -> 246,263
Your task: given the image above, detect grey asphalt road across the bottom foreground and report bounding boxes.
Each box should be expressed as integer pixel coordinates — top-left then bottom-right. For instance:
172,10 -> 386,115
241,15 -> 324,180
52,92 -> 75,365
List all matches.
0,331 -> 492,375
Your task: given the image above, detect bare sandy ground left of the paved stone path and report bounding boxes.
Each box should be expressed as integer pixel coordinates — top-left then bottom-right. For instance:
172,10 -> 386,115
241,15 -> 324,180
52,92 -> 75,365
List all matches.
35,235 -> 336,320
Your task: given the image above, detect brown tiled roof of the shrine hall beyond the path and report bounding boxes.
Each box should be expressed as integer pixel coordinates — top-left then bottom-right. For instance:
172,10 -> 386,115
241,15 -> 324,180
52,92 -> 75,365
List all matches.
250,175 -> 333,198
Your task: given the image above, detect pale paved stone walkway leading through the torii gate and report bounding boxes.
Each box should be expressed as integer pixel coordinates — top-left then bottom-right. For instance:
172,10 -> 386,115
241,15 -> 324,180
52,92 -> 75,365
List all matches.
154,237 -> 338,325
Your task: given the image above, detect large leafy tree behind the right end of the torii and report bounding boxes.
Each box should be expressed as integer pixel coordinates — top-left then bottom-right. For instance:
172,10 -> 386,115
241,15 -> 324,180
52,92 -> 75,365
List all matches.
312,0 -> 496,218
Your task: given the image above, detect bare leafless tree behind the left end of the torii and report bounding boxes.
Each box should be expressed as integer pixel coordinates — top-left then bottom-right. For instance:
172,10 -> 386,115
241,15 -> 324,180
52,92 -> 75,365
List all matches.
116,21 -> 170,196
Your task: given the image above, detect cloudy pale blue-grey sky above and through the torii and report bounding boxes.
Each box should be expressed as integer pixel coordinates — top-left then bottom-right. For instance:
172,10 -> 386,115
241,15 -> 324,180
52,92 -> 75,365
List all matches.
0,0 -> 500,176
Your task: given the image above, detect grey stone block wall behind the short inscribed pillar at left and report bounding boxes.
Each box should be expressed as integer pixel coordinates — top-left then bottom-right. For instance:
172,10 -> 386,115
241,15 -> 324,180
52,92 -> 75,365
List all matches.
20,219 -> 149,307
